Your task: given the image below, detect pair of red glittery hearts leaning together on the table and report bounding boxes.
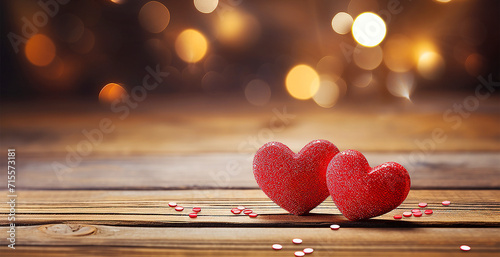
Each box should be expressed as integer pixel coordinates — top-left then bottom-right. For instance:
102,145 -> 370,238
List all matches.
253,140 -> 410,220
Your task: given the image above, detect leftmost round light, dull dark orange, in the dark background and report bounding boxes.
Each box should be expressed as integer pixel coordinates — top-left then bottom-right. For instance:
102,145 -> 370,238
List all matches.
24,34 -> 56,66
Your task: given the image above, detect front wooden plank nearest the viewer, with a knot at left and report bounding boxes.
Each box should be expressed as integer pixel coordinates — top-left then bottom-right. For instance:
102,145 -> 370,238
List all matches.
0,224 -> 500,256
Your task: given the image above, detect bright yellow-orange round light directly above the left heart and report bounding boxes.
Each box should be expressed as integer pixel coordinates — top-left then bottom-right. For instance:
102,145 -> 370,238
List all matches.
285,64 -> 319,100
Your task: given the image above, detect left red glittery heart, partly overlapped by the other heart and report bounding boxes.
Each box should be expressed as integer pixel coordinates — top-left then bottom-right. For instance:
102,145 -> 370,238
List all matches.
253,140 -> 339,215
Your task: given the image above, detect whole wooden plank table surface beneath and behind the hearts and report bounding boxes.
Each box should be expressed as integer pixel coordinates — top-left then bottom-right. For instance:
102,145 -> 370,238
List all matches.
0,93 -> 500,256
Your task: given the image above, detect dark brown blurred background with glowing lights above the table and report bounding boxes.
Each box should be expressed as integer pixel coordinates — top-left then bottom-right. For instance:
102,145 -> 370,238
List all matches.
0,0 -> 500,103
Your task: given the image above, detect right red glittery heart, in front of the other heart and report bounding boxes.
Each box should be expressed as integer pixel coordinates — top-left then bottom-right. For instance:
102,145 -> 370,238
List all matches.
326,150 -> 410,220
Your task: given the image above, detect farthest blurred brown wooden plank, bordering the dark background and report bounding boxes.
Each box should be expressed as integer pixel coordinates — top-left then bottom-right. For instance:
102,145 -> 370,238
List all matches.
0,94 -> 500,156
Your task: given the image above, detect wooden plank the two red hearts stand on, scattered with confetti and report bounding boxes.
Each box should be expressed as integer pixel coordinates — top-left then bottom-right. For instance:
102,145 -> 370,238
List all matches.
0,190 -> 500,227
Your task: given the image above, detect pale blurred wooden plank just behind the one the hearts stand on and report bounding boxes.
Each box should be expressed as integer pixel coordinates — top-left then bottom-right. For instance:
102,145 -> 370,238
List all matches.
0,152 -> 500,190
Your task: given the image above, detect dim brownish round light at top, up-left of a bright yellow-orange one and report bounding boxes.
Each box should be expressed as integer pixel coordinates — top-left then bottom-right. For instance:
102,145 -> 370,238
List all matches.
139,1 -> 170,33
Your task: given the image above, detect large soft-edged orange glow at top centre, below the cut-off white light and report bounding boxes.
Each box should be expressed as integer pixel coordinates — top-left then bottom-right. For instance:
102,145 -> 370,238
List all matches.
217,10 -> 260,48
